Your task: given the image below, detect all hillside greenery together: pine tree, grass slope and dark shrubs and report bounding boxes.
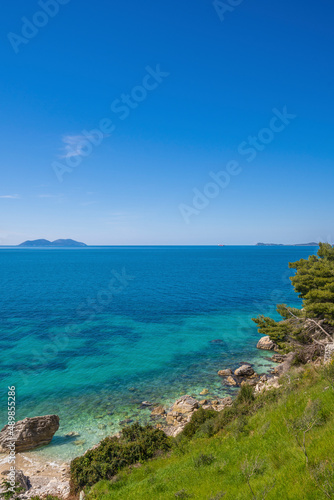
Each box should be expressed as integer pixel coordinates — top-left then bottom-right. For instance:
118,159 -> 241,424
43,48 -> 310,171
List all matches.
71,244 -> 334,500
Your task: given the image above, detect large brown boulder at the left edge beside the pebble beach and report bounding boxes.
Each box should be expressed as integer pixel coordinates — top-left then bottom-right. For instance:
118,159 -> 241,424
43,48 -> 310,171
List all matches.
0,415 -> 59,453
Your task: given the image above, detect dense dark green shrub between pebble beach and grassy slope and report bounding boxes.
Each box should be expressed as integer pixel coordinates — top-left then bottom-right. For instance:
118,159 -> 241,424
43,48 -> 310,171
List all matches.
71,423 -> 172,492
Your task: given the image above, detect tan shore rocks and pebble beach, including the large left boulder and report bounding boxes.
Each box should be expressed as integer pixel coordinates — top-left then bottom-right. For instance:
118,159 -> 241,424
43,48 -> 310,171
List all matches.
0,337 -> 324,499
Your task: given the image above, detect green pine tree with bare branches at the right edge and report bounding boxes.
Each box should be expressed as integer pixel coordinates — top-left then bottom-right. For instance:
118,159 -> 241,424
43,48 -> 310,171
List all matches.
253,243 -> 334,356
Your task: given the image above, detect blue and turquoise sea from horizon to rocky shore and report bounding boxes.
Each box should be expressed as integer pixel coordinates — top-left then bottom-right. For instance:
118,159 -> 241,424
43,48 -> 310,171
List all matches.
0,246 -> 317,460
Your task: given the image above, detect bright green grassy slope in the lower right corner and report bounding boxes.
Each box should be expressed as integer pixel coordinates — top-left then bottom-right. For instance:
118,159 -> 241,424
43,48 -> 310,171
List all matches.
87,366 -> 334,500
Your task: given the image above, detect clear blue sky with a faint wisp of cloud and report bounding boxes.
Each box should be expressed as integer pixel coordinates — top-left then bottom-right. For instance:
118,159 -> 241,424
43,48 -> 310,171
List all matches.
0,0 -> 334,245
